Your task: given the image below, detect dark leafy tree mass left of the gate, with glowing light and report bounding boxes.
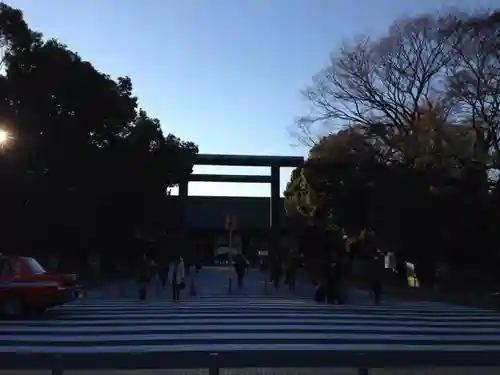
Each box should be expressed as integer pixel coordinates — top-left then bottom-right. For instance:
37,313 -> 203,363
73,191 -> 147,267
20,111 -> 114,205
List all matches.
0,3 -> 198,268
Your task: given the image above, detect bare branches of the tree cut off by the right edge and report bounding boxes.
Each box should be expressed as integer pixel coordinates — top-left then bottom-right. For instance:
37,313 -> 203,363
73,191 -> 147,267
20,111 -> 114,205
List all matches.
447,12 -> 500,160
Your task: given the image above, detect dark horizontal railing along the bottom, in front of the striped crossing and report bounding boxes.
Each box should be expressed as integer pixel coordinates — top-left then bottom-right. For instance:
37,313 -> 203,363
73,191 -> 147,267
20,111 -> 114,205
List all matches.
0,348 -> 500,375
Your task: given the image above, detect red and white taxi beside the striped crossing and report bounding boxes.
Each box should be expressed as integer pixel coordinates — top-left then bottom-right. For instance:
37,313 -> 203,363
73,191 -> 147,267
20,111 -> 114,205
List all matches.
0,254 -> 80,317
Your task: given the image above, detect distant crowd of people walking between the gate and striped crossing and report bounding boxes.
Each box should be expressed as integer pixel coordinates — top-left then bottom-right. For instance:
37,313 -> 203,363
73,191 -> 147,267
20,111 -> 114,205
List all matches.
45,245 -> 383,304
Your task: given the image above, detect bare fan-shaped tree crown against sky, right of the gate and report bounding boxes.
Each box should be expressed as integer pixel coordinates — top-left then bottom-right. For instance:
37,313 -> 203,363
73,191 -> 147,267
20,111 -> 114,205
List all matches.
297,15 -> 458,144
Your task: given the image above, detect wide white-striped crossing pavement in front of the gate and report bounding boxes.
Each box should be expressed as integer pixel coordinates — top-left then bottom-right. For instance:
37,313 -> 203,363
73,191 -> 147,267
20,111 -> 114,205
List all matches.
0,296 -> 500,365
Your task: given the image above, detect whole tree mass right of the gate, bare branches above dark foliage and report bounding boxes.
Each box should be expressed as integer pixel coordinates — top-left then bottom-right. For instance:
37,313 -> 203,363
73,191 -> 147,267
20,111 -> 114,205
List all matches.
285,8 -> 500,288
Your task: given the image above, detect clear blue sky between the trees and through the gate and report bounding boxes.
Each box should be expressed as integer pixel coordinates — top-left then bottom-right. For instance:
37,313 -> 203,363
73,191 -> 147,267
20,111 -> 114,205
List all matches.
7,0 -> 498,196
